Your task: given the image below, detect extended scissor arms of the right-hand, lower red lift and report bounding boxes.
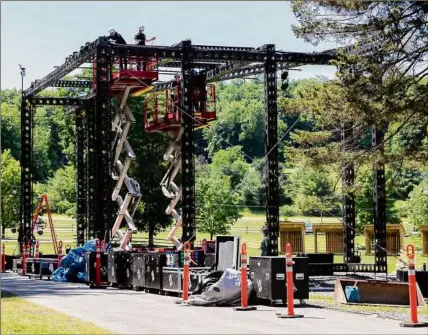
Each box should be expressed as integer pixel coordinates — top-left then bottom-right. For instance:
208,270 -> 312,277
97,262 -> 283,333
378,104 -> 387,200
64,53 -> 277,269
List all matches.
160,128 -> 183,250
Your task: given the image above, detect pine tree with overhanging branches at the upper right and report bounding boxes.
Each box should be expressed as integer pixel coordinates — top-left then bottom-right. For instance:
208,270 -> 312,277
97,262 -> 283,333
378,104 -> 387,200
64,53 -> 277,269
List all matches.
293,0 -> 428,164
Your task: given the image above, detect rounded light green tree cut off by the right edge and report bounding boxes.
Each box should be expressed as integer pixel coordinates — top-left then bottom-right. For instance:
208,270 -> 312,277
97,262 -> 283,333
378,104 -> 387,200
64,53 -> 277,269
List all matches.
407,178 -> 428,227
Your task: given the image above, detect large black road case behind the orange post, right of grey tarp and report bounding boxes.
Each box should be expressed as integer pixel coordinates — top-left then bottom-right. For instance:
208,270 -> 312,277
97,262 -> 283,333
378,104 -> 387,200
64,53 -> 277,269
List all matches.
250,256 -> 309,305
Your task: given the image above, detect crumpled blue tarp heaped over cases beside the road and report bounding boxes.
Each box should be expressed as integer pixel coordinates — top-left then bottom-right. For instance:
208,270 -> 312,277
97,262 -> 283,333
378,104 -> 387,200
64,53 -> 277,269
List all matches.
52,240 -> 100,282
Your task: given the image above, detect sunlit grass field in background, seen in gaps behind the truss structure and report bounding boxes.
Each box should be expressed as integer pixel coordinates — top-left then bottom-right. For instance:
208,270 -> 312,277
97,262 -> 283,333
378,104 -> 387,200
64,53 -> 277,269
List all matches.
5,215 -> 428,273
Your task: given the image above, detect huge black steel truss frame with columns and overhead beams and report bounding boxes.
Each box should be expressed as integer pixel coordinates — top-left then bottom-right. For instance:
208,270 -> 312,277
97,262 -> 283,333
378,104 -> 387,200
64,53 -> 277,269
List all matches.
19,37 -> 386,255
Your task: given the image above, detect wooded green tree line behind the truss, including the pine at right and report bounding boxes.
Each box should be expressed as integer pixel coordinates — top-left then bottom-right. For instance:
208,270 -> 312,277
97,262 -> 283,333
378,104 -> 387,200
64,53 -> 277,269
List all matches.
1,1 -> 428,242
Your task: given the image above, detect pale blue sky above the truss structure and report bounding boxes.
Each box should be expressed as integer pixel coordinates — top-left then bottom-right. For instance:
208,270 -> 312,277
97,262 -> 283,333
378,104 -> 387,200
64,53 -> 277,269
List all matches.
1,1 -> 335,89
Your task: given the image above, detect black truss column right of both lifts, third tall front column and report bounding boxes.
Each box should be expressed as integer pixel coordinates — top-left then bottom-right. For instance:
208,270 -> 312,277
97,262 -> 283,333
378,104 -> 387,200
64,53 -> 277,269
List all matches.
264,44 -> 279,256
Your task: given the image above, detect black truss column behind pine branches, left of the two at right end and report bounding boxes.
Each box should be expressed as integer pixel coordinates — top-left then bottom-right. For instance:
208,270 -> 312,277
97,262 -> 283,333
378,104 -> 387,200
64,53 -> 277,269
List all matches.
341,122 -> 356,263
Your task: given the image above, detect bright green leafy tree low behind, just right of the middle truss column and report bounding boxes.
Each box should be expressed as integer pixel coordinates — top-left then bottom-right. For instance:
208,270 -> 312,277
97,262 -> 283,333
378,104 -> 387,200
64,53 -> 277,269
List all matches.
196,173 -> 240,239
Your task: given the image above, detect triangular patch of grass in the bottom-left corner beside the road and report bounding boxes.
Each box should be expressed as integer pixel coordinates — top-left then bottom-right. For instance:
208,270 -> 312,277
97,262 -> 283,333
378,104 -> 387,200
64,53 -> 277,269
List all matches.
1,291 -> 113,334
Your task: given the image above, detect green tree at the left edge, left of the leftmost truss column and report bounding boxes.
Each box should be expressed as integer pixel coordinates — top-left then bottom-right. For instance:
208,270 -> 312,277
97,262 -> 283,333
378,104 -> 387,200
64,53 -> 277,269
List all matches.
1,149 -> 21,238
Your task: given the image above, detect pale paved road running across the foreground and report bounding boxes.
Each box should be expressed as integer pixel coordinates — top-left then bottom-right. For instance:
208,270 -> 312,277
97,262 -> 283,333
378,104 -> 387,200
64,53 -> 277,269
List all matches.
1,273 -> 428,335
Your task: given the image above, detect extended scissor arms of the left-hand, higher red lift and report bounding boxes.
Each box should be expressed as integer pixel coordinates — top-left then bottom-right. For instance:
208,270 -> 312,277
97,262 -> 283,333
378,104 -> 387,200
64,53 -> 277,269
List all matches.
111,86 -> 141,250
